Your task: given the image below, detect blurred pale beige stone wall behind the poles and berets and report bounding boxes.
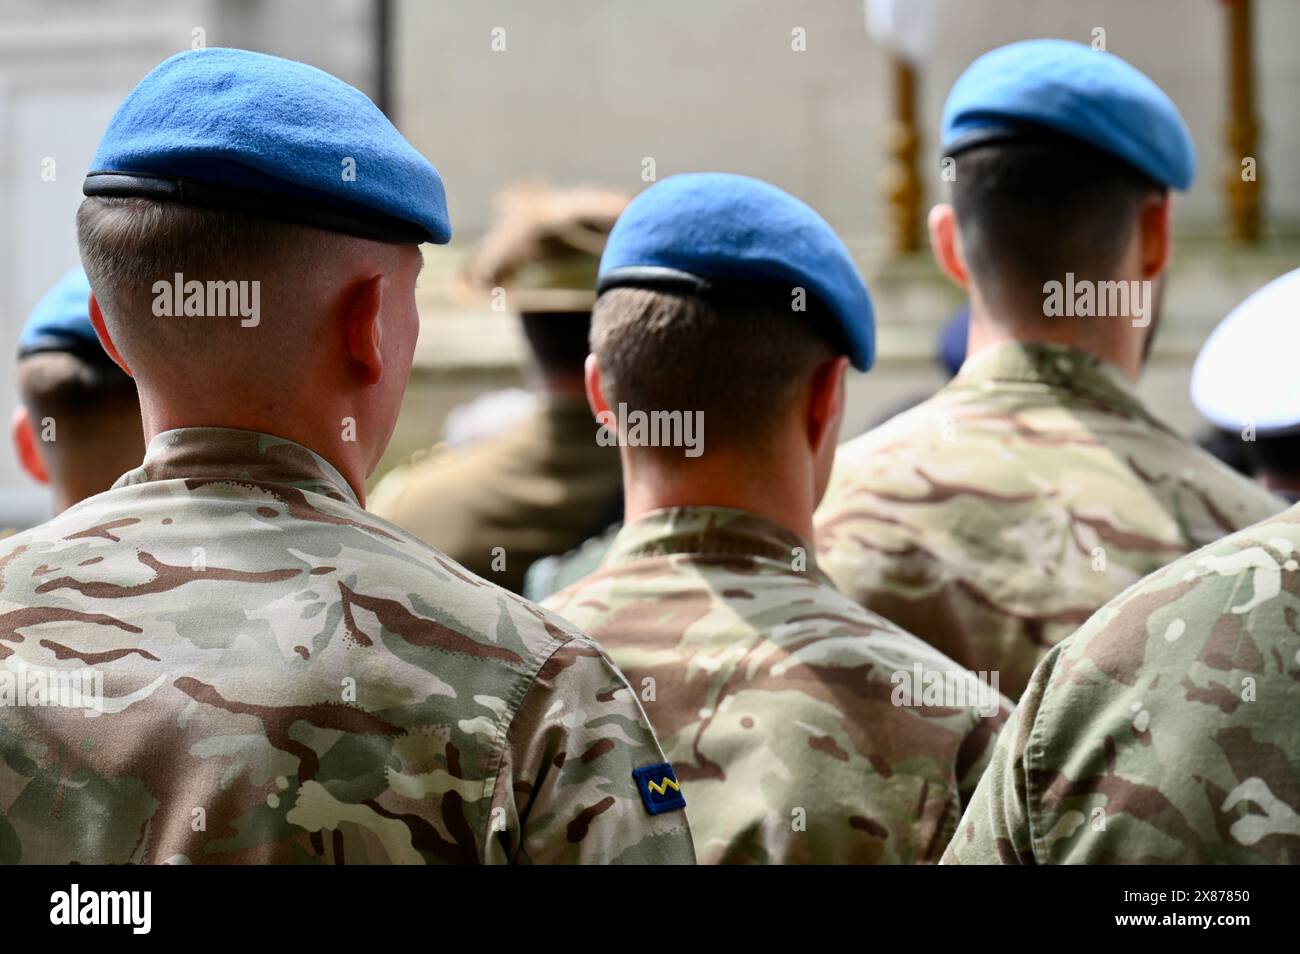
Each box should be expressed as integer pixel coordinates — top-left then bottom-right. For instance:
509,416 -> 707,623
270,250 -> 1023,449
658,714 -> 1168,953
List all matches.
395,0 -> 1300,242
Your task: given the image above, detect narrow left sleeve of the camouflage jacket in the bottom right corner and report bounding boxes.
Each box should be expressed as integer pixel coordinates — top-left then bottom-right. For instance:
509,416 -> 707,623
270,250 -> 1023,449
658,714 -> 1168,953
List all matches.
941,646 -> 1061,864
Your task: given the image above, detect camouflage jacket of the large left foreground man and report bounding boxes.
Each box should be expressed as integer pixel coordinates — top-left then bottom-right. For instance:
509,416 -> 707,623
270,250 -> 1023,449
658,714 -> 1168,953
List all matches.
0,428 -> 693,863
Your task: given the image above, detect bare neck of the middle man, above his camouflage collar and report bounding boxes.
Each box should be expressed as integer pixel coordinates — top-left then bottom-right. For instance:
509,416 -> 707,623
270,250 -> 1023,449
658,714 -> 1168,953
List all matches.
623,447 -> 816,542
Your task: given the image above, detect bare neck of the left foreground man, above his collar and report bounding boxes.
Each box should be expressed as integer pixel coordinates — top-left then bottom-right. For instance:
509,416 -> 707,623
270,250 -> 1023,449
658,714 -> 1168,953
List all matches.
140,390 -> 371,507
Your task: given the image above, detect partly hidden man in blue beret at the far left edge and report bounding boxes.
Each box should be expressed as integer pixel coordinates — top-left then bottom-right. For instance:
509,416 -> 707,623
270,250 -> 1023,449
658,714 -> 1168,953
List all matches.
10,268 -> 144,513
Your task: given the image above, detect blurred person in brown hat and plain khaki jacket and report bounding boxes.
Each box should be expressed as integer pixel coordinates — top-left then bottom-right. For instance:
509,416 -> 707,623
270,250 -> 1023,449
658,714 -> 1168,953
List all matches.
371,185 -> 628,593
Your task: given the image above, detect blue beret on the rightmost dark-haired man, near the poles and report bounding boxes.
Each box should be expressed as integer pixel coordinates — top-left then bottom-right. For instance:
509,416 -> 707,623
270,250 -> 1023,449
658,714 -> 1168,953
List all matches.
943,39 -> 1196,190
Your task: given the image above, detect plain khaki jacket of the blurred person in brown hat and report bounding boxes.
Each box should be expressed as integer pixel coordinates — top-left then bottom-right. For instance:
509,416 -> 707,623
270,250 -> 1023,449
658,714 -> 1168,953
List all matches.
369,399 -> 623,593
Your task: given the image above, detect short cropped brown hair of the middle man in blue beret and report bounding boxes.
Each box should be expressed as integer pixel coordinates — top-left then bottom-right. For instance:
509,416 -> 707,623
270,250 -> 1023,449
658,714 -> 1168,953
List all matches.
592,289 -> 845,447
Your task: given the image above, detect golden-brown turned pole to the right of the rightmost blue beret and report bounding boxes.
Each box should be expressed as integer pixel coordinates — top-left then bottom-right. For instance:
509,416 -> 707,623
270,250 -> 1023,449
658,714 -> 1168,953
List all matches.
1223,0 -> 1260,243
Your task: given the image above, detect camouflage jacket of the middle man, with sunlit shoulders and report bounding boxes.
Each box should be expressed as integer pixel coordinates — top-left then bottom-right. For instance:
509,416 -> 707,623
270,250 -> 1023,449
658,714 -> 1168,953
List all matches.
546,507 -> 1009,863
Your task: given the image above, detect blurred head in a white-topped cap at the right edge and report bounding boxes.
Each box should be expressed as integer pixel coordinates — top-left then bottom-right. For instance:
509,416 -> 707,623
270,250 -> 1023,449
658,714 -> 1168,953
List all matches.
1191,269 -> 1300,503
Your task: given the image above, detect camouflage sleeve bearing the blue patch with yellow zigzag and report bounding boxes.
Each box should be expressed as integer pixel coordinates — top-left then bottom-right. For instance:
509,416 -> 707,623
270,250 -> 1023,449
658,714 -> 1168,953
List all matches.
488,638 -> 696,864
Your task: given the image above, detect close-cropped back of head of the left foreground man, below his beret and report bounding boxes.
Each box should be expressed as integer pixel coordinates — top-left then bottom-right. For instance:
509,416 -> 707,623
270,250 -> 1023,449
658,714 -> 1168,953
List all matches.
77,196 -> 361,390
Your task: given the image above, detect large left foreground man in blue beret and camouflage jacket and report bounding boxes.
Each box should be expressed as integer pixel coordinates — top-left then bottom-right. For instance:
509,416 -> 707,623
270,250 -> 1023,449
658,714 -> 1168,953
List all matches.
0,49 -> 693,863
